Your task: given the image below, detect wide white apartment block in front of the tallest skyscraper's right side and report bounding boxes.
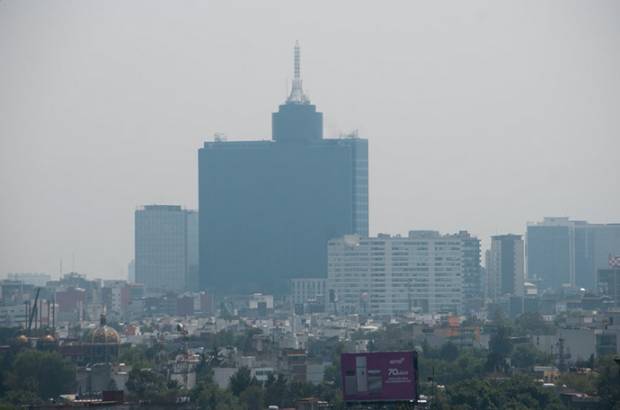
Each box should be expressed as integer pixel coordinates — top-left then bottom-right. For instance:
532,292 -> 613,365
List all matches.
327,231 -> 463,315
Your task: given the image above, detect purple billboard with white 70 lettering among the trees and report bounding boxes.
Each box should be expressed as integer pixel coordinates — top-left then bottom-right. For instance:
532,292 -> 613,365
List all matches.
340,352 -> 418,402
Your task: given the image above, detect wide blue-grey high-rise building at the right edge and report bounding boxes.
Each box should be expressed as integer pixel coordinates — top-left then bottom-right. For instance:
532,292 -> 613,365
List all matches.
526,217 -> 620,289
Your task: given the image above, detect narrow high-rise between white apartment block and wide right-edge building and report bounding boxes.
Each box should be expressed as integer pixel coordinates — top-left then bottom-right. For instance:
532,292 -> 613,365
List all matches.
486,234 -> 525,299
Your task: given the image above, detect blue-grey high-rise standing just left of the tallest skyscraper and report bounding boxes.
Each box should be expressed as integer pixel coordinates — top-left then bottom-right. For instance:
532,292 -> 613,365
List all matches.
134,205 -> 198,291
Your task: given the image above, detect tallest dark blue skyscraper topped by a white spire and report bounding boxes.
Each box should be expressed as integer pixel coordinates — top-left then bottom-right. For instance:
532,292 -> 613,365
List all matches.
198,45 -> 368,294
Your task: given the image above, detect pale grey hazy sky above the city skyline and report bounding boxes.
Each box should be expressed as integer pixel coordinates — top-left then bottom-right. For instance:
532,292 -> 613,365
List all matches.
0,0 -> 620,278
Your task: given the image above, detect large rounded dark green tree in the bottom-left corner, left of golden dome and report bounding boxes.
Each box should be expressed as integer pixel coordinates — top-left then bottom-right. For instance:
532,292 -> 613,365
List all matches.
6,350 -> 75,399
